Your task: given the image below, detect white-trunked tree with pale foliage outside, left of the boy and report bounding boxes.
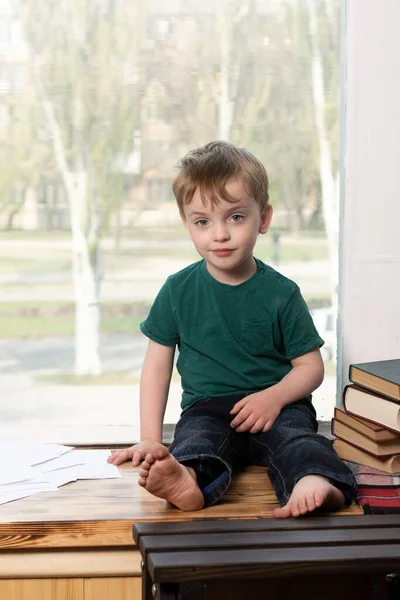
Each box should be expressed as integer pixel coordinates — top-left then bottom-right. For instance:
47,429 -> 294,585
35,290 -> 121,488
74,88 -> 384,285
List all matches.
21,0 -> 142,374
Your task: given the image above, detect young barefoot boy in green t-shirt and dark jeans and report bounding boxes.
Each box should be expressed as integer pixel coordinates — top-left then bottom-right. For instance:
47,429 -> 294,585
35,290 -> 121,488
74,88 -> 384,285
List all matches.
109,142 -> 356,518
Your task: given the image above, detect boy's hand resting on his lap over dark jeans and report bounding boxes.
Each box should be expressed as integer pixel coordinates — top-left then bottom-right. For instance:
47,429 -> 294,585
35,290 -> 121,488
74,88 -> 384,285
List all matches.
230,390 -> 281,433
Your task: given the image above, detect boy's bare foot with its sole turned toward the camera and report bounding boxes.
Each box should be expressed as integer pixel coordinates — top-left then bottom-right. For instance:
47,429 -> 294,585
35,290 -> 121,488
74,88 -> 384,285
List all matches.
139,443 -> 204,510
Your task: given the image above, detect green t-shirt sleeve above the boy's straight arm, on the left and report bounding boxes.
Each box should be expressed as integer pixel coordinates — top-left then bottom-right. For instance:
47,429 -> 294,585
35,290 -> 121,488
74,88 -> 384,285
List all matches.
140,279 -> 179,346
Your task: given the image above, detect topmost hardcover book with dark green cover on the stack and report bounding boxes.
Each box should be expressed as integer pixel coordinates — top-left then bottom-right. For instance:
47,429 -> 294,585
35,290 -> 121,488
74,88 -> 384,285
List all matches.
349,358 -> 400,402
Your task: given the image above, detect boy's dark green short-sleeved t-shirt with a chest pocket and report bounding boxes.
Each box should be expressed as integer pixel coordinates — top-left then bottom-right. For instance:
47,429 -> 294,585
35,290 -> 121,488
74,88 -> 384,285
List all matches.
140,259 -> 324,410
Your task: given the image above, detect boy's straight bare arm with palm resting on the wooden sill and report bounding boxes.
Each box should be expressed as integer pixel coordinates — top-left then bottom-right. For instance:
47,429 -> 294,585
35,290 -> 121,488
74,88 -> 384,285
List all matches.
107,340 -> 175,467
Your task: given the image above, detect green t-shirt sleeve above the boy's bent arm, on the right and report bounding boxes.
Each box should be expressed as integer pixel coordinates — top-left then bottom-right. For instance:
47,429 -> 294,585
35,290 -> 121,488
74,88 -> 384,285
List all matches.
280,286 -> 325,360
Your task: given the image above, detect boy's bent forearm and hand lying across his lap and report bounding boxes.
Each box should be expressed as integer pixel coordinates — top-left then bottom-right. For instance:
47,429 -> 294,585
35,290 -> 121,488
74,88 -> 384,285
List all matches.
231,348 -> 324,433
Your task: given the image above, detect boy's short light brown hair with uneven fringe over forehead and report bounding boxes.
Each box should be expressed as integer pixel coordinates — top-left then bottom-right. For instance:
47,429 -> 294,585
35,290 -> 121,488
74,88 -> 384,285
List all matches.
172,142 -> 269,218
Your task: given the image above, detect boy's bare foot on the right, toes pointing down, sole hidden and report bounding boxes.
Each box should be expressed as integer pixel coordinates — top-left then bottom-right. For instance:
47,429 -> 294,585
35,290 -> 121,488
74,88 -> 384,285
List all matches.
274,475 -> 345,519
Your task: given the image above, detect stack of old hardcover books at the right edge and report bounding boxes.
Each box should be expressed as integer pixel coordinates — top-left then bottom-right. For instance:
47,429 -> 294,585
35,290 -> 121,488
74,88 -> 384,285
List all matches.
332,359 -> 400,473
